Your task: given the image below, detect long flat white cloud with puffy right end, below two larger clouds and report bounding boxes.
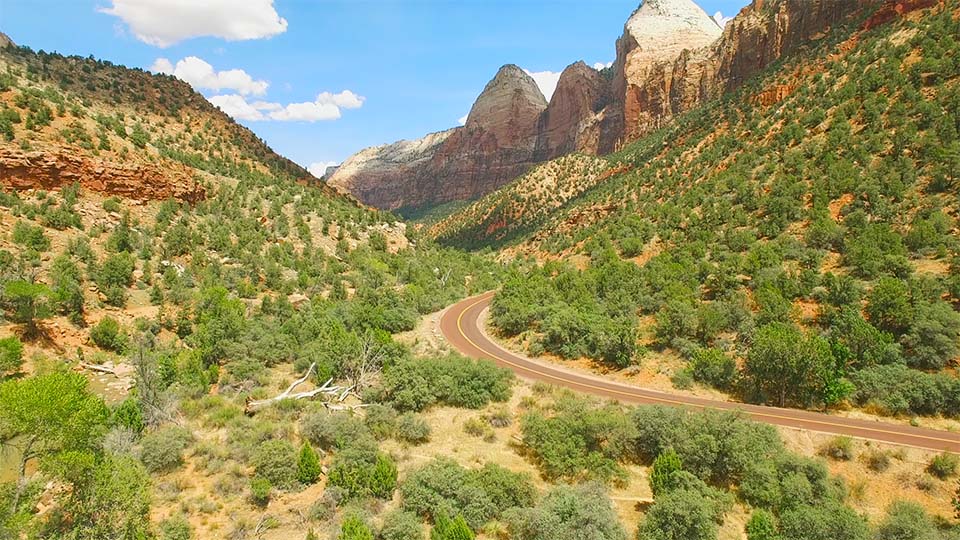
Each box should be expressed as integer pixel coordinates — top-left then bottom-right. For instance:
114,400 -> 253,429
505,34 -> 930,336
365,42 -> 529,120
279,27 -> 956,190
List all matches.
210,90 -> 366,122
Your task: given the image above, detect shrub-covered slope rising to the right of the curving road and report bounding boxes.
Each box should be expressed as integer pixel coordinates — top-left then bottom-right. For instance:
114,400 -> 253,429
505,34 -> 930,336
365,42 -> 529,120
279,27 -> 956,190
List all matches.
429,2 -> 960,417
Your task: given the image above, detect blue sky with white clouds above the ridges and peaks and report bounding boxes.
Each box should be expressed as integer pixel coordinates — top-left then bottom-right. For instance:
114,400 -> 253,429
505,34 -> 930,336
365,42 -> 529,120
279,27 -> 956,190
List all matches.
0,0 -> 748,174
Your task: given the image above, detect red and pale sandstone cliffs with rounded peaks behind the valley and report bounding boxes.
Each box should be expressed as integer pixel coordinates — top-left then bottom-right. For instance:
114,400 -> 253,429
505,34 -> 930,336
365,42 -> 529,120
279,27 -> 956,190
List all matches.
330,0 -> 884,209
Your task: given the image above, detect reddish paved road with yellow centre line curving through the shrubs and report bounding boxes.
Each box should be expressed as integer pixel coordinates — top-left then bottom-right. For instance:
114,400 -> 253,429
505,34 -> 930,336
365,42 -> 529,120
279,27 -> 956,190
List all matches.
440,291 -> 960,452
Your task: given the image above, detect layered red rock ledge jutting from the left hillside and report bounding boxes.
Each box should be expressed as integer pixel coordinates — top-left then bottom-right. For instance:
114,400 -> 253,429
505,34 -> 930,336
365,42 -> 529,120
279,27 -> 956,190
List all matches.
0,146 -> 206,202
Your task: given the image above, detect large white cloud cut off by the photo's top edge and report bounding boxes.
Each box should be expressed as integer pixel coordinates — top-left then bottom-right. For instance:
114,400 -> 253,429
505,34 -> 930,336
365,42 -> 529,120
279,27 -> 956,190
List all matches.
99,0 -> 287,47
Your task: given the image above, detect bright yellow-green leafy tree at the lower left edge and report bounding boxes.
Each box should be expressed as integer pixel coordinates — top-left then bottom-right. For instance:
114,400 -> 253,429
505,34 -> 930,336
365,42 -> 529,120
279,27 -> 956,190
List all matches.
0,372 -> 109,510
